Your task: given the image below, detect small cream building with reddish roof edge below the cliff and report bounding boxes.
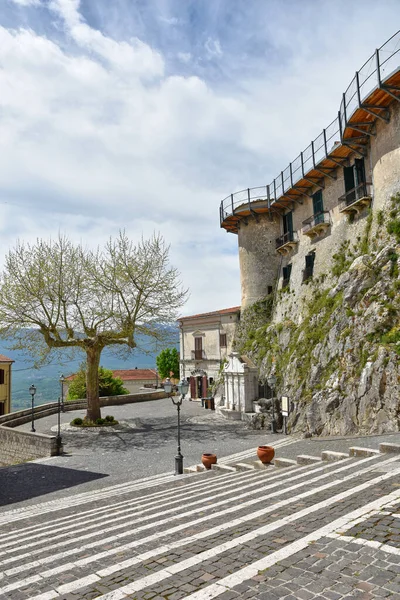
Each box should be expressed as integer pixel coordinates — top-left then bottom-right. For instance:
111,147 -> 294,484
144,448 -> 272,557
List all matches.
178,306 -> 240,399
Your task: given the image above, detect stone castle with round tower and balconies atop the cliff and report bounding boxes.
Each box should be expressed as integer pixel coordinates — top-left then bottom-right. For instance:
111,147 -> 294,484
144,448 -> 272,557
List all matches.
220,32 -> 400,312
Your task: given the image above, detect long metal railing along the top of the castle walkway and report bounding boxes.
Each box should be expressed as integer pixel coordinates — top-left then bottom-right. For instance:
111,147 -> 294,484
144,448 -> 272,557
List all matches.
220,30 -> 400,226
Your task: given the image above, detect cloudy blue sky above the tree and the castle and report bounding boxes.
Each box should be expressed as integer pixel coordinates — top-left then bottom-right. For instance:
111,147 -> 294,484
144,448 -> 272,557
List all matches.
0,0 -> 400,316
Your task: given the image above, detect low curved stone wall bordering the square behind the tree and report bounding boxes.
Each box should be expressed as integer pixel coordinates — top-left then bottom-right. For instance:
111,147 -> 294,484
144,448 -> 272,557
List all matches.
0,390 -> 167,465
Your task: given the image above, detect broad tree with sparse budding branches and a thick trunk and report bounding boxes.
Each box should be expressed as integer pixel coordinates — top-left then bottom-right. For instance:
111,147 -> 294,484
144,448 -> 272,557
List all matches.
0,232 -> 187,421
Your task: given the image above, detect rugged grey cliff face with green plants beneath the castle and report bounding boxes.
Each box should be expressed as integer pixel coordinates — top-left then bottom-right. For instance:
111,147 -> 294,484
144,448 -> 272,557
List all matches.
236,195 -> 400,435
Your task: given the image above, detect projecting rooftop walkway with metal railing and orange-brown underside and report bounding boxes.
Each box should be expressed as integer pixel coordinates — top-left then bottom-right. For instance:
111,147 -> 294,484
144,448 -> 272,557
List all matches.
220,31 -> 400,233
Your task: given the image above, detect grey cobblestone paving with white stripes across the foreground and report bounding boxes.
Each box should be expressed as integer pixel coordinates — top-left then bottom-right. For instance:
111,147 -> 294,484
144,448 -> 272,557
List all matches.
0,454 -> 400,600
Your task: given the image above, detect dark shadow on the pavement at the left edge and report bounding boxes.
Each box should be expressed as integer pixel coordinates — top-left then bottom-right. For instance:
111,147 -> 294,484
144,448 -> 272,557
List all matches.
0,463 -> 108,506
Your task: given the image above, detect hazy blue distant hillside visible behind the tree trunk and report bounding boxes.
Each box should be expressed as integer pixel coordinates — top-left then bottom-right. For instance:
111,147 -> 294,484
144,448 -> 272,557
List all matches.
0,333 -> 179,411
